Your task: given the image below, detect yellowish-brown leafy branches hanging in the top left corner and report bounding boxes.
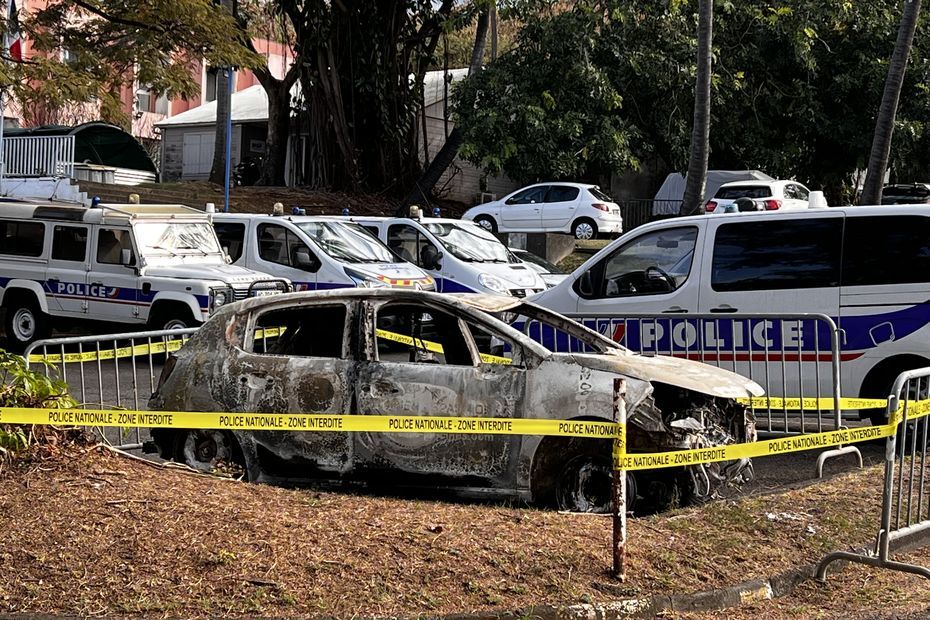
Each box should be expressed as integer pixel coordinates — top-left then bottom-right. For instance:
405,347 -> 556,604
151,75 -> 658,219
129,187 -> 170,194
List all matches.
0,0 -> 263,124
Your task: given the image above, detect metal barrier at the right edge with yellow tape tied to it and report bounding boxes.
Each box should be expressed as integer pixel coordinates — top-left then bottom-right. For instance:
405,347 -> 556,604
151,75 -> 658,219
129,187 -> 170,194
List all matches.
817,368 -> 930,580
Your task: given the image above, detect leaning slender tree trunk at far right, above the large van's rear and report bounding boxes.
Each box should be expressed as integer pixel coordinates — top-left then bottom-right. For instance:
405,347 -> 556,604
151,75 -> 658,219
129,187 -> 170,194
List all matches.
859,0 -> 920,205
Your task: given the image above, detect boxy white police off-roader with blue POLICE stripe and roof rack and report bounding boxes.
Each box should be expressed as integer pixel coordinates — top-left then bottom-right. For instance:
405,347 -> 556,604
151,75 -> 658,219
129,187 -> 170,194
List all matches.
0,202 -> 290,349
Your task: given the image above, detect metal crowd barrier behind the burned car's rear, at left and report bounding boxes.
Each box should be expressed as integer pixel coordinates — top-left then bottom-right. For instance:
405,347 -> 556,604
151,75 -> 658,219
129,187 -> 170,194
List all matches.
23,327 -> 197,449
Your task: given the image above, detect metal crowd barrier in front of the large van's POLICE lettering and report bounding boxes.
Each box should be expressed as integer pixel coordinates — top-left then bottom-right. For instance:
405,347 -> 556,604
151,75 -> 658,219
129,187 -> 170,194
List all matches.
524,313 -> 861,473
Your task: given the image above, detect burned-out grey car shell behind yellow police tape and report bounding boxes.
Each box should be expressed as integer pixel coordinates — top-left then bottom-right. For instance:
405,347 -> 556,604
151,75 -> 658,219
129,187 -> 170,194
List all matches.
149,288 -> 762,511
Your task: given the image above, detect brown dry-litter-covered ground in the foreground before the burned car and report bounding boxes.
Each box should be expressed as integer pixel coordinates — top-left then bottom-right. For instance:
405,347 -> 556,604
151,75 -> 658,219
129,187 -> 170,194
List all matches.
0,448 -> 912,617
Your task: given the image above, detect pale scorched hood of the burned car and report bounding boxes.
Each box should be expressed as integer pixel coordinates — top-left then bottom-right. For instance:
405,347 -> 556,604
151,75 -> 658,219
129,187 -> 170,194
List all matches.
571,350 -> 765,398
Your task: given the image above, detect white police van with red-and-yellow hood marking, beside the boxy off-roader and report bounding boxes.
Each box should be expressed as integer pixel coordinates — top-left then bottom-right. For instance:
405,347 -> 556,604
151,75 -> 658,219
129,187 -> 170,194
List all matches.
213,213 -> 435,291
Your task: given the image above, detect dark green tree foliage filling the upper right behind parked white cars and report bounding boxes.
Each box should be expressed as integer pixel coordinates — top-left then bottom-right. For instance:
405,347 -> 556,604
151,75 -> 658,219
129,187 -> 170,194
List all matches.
457,0 -> 930,203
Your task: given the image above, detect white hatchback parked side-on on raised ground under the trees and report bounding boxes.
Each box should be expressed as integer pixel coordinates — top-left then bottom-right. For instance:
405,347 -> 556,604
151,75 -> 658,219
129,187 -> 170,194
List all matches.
462,183 -> 623,239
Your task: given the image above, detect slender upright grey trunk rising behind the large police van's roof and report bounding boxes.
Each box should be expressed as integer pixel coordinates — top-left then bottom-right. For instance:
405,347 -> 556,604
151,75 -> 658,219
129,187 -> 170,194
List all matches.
680,0 -> 714,215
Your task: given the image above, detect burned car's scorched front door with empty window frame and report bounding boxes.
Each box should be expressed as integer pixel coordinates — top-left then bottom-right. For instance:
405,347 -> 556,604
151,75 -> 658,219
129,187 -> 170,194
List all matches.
353,299 -> 538,495
